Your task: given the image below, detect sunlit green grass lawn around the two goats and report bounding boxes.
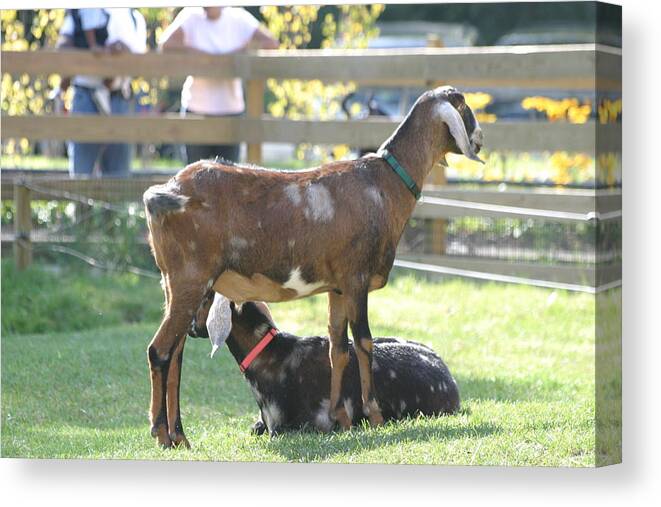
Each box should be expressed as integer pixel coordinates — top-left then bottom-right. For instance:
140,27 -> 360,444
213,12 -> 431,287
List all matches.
1,262 -> 595,466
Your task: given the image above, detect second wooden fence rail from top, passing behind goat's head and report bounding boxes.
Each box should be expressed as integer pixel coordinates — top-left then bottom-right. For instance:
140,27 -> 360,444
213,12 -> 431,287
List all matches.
2,115 -> 621,153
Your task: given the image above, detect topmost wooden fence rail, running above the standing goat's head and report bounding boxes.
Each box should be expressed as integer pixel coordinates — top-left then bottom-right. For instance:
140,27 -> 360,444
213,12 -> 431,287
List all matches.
2,44 -> 622,91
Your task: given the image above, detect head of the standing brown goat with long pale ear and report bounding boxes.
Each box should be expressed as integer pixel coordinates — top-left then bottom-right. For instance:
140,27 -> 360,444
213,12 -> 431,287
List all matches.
420,86 -> 484,163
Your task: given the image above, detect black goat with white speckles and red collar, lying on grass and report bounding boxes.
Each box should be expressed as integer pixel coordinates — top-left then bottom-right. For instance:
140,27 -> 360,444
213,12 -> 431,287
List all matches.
190,294 -> 460,435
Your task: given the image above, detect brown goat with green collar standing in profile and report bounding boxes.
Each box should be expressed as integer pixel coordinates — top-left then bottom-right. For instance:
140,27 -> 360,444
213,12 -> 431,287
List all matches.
144,87 -> 482,447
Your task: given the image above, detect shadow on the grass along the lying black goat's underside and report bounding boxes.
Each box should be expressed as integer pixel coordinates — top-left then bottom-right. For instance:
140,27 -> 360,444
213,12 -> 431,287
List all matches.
266,416 -> 502,461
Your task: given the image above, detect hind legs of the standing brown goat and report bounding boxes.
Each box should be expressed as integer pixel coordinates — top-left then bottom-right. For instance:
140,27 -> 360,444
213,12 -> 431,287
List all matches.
147,283 -> 204,447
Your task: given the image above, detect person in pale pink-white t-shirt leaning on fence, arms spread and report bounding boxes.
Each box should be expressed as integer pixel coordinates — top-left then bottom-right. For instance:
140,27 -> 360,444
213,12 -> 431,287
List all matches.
160,7 -> 279,163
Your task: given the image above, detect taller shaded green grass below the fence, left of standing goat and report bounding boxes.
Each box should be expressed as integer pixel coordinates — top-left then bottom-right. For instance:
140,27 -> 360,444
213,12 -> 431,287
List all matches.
2,259 -> 163,338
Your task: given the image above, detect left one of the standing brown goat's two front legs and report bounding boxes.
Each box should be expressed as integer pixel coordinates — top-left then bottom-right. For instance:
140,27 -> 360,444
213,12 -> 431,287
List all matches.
328,292 -> 352,430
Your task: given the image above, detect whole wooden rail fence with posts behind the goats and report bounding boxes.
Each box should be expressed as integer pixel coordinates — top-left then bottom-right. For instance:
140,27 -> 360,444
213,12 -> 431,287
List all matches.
2,44 -> 621,287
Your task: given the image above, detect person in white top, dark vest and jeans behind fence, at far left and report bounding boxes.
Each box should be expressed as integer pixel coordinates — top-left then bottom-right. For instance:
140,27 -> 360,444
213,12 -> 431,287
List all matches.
57,8 -> 147,176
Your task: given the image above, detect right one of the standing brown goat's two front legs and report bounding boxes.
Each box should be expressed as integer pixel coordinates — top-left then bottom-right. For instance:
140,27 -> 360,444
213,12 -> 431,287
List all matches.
346,290 -> 383,426
